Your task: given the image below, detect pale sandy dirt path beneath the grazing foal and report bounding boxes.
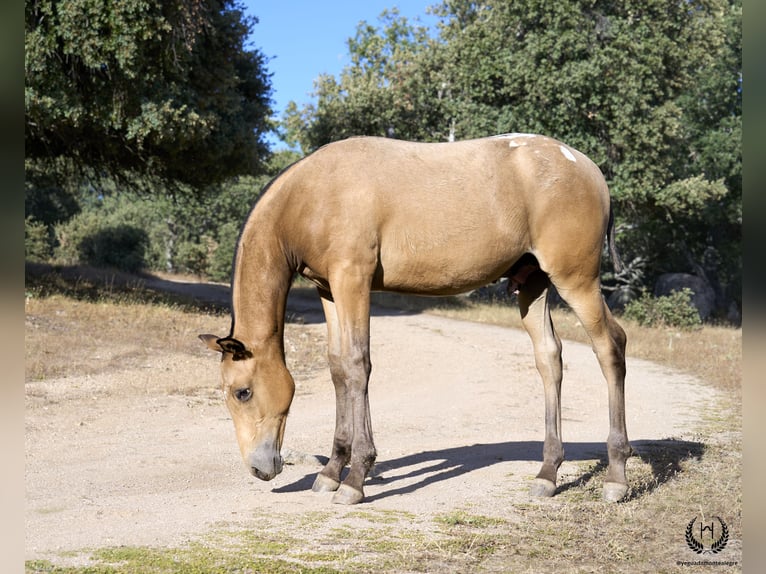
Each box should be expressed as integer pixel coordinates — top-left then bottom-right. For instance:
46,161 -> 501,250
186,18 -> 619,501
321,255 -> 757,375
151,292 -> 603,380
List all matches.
25,282 -> 716,561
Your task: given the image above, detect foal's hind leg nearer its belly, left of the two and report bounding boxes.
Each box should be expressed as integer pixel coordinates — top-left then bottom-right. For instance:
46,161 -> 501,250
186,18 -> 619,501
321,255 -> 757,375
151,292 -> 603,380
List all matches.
518,270 -> 564,496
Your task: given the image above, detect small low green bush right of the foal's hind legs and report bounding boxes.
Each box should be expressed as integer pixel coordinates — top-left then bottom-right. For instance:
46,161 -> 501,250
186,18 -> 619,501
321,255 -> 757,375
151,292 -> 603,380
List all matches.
623,287 -> 702,329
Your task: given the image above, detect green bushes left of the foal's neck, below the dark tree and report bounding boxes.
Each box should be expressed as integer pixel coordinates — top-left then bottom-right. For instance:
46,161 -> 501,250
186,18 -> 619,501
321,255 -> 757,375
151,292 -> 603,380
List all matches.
48,177 -> 266,282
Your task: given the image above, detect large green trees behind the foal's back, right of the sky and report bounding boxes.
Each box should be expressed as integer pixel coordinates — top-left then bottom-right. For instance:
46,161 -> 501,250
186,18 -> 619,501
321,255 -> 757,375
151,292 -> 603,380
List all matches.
285,0 -> 742,318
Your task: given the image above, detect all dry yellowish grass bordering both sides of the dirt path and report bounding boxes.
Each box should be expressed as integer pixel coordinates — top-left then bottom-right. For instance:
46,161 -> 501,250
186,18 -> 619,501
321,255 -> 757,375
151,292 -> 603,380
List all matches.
26,273 -> 742,572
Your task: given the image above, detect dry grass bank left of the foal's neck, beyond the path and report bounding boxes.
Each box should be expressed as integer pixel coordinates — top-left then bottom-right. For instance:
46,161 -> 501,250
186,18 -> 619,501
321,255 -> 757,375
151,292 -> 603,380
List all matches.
24,273 -> 228,381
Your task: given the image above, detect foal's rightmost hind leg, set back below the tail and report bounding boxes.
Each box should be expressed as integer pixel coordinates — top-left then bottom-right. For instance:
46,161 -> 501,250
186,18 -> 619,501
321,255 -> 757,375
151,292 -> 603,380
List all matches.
557,278 -> 633,502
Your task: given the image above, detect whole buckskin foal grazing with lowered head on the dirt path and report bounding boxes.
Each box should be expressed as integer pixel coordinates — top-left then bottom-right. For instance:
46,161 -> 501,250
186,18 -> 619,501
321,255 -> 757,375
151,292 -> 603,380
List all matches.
200,134 -> 632,504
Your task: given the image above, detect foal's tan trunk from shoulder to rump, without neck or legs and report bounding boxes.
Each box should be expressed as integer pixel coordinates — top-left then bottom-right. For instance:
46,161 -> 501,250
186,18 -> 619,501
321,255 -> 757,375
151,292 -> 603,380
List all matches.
280,134 -> 608,294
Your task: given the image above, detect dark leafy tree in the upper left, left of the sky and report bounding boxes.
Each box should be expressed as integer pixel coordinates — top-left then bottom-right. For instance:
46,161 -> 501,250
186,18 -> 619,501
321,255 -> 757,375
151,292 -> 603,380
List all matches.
25,0 -> 271,187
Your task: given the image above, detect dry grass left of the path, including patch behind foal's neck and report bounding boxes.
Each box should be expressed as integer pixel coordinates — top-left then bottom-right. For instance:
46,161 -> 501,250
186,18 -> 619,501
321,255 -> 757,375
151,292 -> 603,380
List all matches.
24,266 -> 326,388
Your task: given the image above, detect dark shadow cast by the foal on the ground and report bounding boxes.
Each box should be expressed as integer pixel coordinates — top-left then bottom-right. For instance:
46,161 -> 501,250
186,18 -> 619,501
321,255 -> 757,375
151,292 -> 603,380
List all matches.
274,439 -> 705,502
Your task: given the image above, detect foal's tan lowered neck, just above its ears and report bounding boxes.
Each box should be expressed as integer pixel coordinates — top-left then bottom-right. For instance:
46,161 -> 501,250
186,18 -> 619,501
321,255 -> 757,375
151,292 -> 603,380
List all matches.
232,225 -> 292,349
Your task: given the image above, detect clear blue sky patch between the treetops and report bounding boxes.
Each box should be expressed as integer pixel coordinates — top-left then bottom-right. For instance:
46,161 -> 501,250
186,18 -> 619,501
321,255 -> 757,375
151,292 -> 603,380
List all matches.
243,0 -> 438,146
